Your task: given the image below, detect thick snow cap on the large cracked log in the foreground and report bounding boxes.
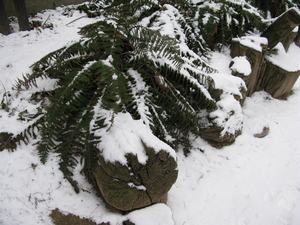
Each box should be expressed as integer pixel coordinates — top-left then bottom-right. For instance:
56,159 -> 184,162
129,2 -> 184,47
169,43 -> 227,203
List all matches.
95,113 -> 176,165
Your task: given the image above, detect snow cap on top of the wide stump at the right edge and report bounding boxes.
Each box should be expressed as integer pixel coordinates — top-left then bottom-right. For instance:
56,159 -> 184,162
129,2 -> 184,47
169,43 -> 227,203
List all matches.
266,42 -> 300,72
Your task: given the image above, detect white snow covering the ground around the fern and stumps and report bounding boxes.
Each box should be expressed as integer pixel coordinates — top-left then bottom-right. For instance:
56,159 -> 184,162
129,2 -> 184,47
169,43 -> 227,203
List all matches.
0,5 -> 300,225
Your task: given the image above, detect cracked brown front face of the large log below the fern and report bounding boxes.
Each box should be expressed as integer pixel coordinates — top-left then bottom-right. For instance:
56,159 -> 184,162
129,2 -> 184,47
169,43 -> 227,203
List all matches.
93,143 -> 178,211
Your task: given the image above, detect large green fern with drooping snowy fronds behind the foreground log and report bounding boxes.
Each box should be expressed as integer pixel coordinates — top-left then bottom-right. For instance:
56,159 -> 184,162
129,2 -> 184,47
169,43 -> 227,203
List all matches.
16,11 -> 216,191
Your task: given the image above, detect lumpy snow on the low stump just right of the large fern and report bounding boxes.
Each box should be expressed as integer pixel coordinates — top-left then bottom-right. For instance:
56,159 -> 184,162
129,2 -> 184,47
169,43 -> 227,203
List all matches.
209,73 -> 246,136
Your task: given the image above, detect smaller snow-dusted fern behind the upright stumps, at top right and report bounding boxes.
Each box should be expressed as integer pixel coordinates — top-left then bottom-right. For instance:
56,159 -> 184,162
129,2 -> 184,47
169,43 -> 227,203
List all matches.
183,0 -> 266,50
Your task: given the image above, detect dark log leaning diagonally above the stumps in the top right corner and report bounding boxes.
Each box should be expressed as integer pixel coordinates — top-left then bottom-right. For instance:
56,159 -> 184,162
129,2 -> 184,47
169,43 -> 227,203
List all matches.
261,8 -> 300,49
